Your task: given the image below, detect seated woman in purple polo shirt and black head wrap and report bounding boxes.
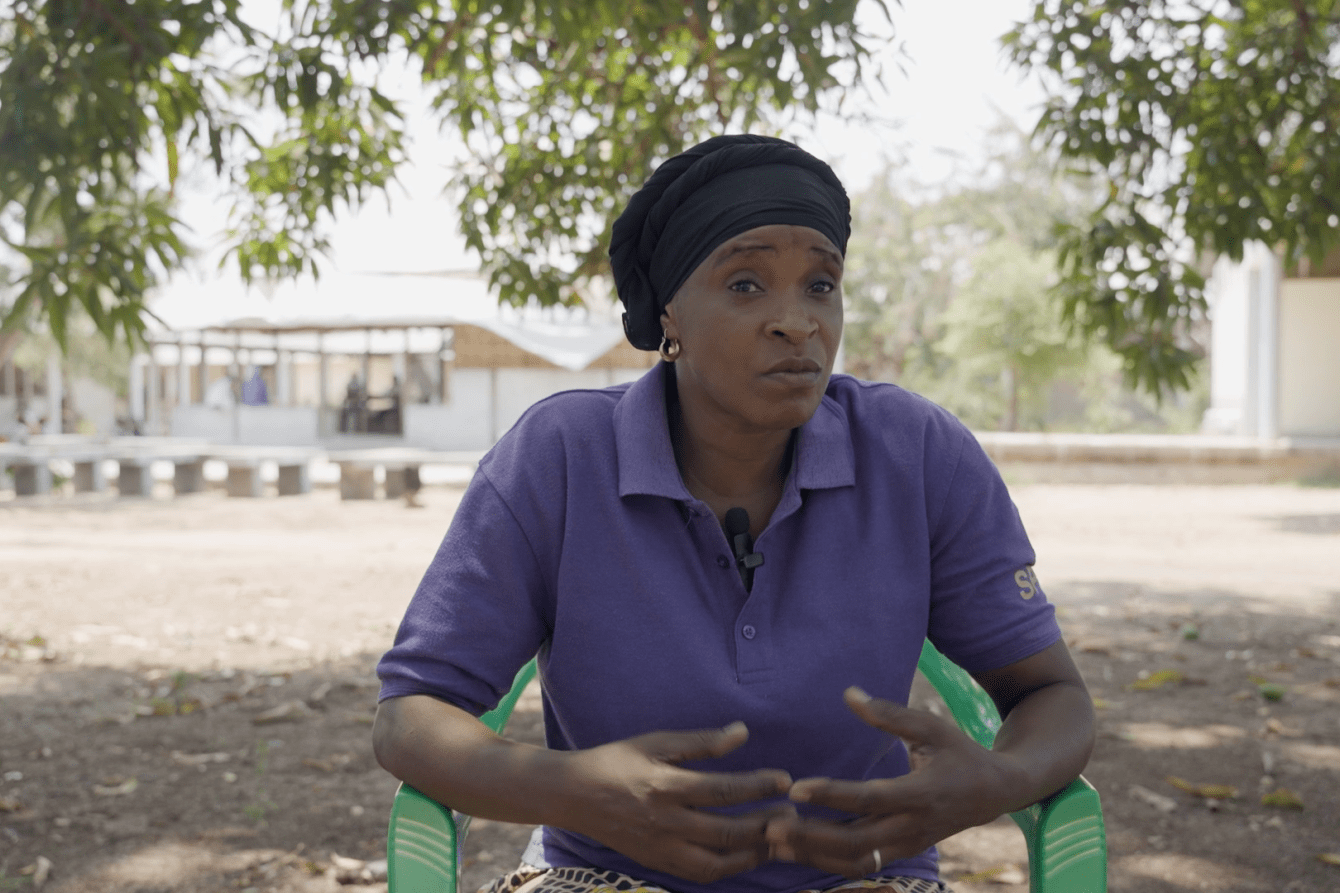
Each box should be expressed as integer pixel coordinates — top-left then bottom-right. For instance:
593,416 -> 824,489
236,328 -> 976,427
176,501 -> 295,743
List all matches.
374,137 -> 1093,893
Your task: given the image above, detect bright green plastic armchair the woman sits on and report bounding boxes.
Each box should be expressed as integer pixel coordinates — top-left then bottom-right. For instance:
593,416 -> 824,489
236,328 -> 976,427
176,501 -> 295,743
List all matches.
386,642 -> 1107,893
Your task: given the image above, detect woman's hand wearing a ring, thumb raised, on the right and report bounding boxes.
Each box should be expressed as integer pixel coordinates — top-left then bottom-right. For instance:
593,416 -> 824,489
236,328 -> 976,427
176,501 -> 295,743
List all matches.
768,688 -> 1026,878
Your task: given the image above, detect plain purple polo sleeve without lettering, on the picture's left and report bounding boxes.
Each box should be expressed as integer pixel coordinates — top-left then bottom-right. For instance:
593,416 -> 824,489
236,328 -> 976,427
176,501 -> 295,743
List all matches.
377,468 -> 549,716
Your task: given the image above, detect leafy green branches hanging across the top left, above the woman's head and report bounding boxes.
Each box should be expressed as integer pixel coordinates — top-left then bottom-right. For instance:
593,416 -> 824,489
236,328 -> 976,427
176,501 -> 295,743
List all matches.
0,0 -> 891,353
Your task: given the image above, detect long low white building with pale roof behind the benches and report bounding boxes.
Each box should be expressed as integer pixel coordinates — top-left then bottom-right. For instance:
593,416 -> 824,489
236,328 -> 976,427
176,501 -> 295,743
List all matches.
138,264 -> 655,451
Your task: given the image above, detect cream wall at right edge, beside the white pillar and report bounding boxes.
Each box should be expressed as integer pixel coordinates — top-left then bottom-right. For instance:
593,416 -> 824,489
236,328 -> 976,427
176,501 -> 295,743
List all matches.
1280,279 -> 1340,437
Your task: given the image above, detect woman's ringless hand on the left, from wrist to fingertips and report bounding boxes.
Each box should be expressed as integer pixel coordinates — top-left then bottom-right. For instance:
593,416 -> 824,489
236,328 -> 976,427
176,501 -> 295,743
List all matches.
561,723 -> 795,884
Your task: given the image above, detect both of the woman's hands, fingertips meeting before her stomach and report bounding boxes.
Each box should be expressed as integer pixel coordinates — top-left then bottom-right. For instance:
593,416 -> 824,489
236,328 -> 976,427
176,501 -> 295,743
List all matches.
560,688 -> 1018,884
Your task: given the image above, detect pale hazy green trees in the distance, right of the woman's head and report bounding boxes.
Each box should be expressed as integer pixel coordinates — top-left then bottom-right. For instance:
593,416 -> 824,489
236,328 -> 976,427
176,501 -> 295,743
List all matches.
843,121 -> 1203,430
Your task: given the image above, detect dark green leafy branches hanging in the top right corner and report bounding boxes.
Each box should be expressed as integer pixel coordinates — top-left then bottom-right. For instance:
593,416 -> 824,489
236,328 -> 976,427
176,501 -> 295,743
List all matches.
1006,0 -> 1340,393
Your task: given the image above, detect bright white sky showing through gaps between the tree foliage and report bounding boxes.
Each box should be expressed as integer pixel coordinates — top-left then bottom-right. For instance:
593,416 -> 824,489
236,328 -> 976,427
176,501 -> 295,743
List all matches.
172,0 -> 1041,285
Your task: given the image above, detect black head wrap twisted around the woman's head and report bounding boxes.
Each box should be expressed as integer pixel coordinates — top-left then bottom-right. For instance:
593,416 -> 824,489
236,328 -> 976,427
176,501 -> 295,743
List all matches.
610,134 -> 851,350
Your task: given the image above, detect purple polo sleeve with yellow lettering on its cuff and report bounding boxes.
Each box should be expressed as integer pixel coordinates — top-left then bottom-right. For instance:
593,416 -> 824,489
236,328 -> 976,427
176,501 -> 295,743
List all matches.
927,429 -> 1061,672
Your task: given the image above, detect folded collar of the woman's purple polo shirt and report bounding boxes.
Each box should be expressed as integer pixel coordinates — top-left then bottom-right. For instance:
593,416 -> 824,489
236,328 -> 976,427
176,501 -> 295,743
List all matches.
614,363 -> 856,500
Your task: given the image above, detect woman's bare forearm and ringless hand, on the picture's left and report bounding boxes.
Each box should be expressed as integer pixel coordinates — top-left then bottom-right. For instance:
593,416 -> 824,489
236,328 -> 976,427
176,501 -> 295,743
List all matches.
373,695 -> 796,884
